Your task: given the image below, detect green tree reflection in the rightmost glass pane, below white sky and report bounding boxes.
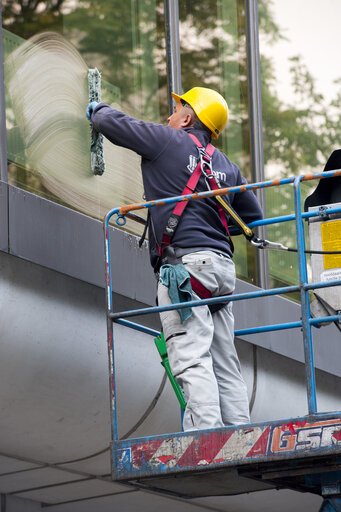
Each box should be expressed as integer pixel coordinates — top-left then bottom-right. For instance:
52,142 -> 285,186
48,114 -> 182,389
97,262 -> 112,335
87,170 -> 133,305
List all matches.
259,0 -> 341,284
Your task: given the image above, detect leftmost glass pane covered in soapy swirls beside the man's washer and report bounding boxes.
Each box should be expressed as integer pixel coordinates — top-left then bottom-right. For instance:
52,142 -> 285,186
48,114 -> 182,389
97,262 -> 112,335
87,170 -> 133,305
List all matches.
2,0 -> 168,235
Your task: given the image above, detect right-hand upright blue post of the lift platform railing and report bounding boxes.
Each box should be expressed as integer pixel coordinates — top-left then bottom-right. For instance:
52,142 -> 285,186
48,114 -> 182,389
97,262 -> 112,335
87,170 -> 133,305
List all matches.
294,176 -> 317,414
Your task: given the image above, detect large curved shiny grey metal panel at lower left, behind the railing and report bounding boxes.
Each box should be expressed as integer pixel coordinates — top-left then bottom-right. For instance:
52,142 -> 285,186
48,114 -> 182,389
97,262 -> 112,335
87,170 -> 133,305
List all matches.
0,253 -> 181,460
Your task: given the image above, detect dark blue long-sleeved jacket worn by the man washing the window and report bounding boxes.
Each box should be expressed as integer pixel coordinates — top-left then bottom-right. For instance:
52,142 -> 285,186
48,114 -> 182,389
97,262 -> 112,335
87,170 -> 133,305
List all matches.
91,103 -> 263,267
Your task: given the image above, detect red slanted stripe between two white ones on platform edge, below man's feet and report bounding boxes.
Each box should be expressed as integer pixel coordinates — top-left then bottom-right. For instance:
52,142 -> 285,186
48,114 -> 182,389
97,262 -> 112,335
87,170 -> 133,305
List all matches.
177,431 -> 233,468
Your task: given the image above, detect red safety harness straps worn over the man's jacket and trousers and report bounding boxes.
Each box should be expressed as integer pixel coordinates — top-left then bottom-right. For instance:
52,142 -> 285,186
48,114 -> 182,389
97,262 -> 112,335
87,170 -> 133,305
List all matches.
158,133 -> 234,313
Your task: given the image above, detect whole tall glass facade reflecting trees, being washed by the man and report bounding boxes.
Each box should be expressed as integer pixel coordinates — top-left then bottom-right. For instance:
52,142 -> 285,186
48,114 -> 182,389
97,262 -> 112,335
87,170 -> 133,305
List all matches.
2,0 -> 318,287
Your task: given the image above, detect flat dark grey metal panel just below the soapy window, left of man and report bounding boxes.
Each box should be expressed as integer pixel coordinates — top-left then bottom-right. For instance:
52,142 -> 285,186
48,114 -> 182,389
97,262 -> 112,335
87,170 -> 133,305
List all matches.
9,186 -> 155,304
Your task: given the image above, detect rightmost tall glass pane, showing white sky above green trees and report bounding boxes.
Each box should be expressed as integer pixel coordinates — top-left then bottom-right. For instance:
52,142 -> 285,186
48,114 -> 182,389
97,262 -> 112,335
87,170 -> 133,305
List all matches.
259,0 -> 341,286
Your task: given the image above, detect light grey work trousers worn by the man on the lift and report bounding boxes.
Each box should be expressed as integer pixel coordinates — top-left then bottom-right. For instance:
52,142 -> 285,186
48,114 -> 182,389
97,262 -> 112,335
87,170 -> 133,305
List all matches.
158,251 -> 250,430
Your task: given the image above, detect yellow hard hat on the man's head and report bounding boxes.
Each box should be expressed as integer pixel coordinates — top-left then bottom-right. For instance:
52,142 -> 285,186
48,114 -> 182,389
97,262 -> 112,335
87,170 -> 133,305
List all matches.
172,87 -> 228,139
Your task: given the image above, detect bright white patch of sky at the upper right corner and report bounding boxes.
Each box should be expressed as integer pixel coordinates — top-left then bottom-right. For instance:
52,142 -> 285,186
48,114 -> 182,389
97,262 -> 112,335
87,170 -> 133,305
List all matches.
260,0 -> 341,105
